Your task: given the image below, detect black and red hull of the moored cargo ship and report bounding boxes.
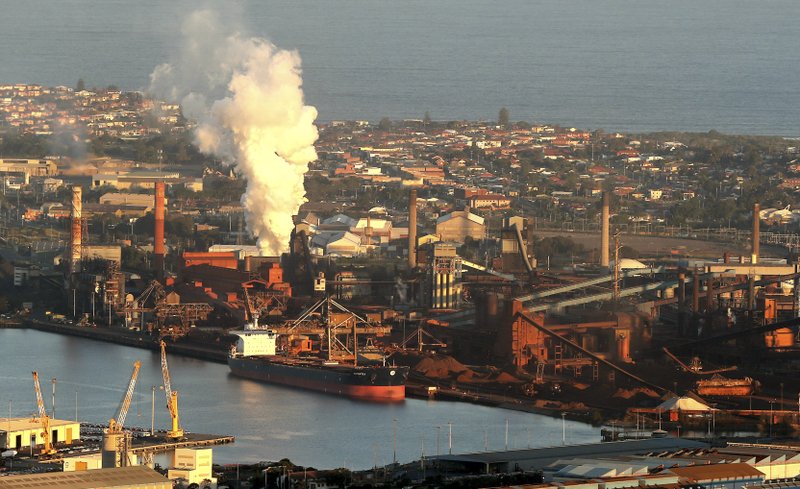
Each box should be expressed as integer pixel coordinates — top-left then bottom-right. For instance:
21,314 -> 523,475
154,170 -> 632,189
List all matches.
228,357 -> 408,402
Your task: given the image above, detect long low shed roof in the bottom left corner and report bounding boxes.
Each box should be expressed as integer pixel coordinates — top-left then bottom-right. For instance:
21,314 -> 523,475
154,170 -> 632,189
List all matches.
0,466 -> 172,489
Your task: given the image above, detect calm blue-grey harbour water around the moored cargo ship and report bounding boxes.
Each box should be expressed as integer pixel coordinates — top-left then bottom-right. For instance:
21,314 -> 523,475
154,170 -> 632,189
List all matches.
0,330 -> 599,469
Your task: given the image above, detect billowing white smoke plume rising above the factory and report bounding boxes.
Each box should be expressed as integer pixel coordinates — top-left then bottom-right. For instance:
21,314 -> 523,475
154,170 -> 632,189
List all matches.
150,10 -> 318,255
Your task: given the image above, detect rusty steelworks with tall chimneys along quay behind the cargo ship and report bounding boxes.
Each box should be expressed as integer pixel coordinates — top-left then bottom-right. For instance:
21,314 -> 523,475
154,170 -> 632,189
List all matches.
40,175 -> 800,430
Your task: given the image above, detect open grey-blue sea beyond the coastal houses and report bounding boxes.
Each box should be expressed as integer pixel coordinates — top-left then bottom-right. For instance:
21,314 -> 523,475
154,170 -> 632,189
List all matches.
0,0 -> 800,136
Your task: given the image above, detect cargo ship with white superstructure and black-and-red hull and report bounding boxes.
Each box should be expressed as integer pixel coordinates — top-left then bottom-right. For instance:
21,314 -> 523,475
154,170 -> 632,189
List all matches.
228,318 -> 409,402
